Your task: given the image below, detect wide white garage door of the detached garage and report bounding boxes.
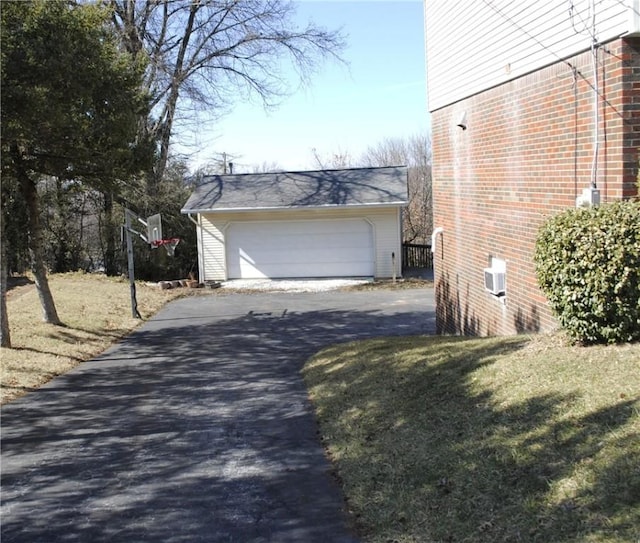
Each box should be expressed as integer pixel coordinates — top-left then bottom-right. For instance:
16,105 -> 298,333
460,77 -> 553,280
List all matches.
226,219 -> 374,279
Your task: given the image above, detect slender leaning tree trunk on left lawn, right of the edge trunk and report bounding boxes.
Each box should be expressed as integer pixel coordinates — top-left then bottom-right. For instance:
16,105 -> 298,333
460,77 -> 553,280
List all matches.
14,151 -> 62,324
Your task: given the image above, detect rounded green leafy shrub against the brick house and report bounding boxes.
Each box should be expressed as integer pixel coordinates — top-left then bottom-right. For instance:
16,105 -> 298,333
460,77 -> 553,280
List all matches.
534,201 -> 640,343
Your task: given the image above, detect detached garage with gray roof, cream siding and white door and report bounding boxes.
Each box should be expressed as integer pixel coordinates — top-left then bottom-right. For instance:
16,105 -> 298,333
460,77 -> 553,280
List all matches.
182,167 -> 407,281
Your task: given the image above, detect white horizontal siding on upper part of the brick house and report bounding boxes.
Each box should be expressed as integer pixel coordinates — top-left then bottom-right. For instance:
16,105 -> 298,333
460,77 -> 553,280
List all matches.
425,0 -> 640,111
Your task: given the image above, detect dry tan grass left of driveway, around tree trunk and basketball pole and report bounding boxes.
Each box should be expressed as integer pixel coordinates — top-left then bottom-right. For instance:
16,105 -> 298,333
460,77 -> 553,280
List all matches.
0,273 -> 191,403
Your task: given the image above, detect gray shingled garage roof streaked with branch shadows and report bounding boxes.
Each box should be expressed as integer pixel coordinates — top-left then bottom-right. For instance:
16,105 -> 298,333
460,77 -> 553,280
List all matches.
182,166 -> 408,213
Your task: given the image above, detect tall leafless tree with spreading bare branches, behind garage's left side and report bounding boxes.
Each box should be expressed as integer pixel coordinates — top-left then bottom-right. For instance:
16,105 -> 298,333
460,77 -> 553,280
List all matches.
109,0 -> 344,189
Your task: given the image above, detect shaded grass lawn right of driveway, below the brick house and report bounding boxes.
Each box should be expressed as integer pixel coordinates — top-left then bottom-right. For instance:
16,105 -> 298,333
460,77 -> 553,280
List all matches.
304,336 -> 640,543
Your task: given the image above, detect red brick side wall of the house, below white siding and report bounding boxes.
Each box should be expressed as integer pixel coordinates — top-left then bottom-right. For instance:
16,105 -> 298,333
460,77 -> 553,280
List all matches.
432,38 -> 640,335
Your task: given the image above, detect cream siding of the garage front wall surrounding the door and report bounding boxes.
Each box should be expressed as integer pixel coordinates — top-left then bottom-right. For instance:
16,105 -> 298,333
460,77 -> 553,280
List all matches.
201,207 -> 401,281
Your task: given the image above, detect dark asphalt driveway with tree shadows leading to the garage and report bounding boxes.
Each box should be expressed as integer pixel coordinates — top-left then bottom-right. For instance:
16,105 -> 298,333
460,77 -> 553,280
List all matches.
1,289 -> 435,543
